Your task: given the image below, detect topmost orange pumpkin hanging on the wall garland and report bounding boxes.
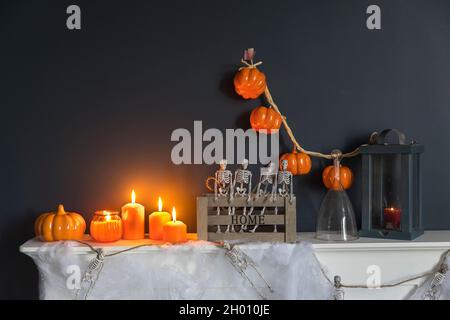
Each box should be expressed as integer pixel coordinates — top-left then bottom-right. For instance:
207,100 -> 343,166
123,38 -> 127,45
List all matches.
234,67 -> 266,99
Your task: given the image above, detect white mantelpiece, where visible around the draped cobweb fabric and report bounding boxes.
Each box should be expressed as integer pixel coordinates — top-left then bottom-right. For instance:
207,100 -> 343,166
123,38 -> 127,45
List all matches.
20,230 -> 450,299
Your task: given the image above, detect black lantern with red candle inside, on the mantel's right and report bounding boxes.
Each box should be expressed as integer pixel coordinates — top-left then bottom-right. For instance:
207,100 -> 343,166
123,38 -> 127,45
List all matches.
360,129 -> 424,240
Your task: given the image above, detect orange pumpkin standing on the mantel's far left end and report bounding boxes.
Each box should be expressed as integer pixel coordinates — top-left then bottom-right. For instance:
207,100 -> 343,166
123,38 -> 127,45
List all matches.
34,204 -> 86,241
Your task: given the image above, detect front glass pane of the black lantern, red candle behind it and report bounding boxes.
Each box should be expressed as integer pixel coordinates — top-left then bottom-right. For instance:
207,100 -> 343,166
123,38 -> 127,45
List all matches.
371,154 -> 402,231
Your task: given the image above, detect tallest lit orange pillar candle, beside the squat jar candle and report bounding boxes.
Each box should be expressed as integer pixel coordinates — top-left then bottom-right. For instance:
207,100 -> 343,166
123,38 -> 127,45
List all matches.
122,190 -> 145,240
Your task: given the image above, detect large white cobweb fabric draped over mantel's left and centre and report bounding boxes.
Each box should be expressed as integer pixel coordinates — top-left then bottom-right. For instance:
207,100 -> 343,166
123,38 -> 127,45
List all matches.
24,241 -> 333,300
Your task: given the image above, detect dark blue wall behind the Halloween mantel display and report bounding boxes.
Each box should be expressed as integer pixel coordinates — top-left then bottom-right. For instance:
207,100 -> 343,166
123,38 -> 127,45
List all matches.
0,0 -> 450,298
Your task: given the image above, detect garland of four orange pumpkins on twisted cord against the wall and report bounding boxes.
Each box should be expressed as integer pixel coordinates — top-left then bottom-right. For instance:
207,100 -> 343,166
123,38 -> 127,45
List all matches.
234,48 -> 360,189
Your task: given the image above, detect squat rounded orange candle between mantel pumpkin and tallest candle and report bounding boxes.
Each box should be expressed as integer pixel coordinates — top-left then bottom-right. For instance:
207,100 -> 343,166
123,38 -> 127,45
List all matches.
90,210 -> 122,242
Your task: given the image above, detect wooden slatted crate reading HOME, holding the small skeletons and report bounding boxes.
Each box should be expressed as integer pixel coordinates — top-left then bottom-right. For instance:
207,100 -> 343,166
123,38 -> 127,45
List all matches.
197,194 -> 297,242
